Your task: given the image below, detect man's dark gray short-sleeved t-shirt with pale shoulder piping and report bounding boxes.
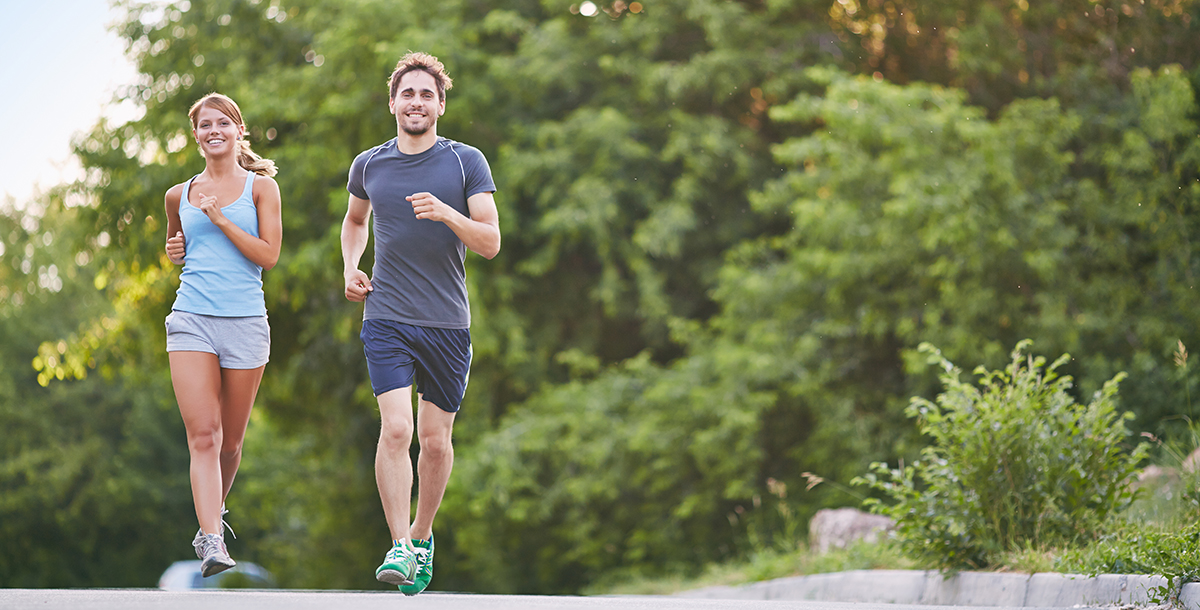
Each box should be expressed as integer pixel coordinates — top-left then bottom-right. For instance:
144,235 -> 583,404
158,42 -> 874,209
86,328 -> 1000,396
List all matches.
346,137 -> 496,328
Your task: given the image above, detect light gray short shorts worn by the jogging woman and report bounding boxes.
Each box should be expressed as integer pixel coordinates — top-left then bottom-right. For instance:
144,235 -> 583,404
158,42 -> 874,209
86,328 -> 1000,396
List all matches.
167,311 -> 271,369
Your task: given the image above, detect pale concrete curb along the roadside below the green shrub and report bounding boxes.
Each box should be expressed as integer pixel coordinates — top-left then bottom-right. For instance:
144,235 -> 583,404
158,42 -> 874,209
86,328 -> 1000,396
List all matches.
679,570 -> 1200,610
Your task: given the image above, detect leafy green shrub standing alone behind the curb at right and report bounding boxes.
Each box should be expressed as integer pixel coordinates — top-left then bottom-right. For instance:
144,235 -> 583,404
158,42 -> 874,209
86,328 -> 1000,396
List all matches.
856,340 -> 1146,569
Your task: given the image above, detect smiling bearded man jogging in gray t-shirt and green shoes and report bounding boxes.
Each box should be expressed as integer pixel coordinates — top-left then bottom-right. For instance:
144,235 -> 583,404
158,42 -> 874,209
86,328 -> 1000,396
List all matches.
342,53 -> 500,596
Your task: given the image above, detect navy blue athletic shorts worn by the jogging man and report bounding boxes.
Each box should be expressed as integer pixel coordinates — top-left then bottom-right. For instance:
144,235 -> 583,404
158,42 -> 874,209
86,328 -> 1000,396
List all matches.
359,319 -> 472,413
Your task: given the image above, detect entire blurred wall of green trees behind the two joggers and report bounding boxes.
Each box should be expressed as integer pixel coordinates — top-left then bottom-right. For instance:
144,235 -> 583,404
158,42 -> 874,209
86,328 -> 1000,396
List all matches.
0,0 -> 1200,593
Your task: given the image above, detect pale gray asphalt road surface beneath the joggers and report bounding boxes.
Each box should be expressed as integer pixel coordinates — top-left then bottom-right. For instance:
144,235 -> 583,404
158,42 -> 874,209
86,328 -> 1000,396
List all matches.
0,588 -> 1094,610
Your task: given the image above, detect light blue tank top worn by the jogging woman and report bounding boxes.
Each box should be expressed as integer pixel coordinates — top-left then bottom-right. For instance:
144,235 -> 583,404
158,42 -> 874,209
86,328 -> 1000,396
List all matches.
172,172 -> 266,318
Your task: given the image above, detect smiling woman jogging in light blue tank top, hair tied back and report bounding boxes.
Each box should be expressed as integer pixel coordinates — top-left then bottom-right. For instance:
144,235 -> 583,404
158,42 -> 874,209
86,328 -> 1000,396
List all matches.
166,94 -> 283,576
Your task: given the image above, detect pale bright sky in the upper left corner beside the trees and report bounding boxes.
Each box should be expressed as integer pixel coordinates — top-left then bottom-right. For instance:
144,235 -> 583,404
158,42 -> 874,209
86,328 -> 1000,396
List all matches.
0,0 -> 137,208
